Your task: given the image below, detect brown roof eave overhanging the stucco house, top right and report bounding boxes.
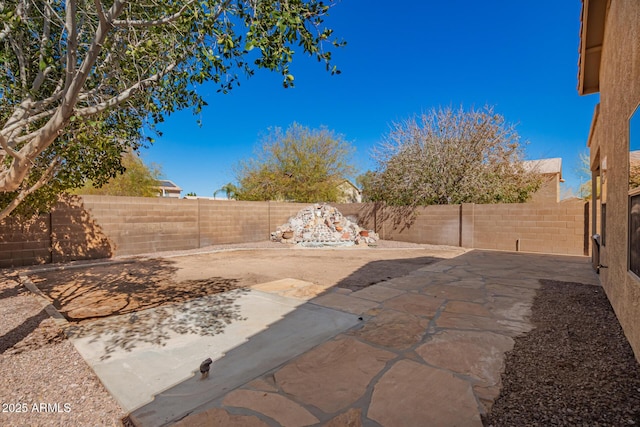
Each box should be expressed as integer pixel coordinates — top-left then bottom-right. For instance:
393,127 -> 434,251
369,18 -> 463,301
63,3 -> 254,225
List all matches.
578,0 -> 608,95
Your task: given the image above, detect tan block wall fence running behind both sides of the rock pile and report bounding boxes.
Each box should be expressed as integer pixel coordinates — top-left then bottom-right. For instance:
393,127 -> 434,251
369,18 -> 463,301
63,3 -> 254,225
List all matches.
0,196 -> 590,268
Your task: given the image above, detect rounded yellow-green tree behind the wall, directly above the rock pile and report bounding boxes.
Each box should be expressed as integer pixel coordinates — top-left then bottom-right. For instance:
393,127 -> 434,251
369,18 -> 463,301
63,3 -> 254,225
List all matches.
237,123 -> 354,203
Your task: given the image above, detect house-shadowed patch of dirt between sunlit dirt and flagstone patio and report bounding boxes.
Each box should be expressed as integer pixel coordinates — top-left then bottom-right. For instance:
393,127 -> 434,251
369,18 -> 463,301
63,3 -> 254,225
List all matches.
336,256 -> 444,292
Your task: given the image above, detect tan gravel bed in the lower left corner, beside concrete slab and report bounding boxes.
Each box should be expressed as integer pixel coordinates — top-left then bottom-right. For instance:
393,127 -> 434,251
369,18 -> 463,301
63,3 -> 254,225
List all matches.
0,272 -> 124,427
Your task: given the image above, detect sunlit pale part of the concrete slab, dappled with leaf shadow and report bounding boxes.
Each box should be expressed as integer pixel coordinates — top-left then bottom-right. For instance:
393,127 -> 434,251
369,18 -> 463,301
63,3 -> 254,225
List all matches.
69,290 -> 302,411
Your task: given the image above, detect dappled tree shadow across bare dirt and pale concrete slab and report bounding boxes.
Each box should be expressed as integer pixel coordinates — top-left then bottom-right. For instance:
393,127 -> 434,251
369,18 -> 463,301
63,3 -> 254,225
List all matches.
31,259 -> 246,360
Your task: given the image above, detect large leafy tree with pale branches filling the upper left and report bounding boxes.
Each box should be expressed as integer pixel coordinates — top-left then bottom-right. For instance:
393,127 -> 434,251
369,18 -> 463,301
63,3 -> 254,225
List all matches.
0,0 -> 342,219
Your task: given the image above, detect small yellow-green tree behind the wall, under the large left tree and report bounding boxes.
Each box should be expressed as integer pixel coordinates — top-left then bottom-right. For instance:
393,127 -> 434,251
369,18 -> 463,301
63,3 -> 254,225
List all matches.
73,151 -> 161,197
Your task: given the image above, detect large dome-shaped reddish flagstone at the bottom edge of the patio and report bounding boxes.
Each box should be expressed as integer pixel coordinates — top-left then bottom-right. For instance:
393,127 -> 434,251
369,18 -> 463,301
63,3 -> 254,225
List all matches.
367,360 -> 482,427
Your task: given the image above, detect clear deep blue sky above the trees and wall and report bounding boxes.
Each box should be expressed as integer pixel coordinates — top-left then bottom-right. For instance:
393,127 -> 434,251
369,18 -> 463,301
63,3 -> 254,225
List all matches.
142,0 -> 598,196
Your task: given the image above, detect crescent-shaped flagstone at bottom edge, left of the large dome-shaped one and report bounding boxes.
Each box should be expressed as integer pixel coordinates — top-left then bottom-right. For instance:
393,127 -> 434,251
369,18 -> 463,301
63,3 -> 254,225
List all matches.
222,390 -> 319,427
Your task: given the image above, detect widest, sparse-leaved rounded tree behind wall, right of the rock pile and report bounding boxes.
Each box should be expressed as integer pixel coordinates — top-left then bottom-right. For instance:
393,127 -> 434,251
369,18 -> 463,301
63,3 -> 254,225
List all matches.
369,107 -> 541,206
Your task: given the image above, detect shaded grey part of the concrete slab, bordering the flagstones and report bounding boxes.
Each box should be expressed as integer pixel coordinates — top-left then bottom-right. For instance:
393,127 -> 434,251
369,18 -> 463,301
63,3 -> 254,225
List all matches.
130,300 -> 360,426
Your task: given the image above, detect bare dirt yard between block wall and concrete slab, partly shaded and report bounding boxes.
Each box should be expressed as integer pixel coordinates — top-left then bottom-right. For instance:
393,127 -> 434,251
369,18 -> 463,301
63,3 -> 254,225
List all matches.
29,247 -> 462,322
